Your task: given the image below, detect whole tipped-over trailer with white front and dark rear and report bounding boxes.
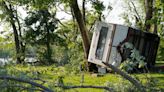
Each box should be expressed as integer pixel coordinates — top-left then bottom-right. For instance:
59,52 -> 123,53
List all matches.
88,22 -> 160,67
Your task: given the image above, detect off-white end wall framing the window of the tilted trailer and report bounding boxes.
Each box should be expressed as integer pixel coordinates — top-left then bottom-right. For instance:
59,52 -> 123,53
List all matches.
88,22 -> 113,65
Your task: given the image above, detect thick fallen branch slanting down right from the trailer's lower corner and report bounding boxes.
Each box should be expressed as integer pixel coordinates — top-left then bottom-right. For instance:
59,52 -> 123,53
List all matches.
103,62 -> 145,92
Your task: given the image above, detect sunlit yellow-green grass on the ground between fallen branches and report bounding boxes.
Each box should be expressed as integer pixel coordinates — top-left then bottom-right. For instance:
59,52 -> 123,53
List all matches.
1,65 -> 164,92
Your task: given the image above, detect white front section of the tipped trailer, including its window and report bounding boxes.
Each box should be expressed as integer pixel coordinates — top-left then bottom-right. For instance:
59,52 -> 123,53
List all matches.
88,22 -> 128,66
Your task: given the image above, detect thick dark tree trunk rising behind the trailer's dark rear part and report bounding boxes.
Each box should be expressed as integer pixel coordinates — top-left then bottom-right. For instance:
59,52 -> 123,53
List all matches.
145,0 -> 153,32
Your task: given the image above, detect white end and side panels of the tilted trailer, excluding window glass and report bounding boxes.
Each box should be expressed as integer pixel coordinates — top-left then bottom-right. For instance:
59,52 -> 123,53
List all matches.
88,22 -> 128,66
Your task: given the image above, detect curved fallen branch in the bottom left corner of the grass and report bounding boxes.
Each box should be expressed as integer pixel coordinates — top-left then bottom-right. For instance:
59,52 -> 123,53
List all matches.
0,76 -> 53,92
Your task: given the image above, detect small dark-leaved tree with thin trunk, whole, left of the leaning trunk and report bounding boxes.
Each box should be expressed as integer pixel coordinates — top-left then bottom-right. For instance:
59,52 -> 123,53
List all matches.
25,10 -> 63,63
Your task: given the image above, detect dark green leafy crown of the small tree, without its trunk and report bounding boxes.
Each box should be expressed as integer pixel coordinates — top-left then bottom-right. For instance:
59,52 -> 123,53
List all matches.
25,10 -> 58,44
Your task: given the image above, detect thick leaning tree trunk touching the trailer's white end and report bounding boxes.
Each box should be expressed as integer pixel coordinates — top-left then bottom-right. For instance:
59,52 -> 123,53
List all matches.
71,0 -> 90,58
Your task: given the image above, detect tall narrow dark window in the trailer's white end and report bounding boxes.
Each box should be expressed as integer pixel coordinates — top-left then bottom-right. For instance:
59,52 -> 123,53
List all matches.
96,27 -> 108,60
